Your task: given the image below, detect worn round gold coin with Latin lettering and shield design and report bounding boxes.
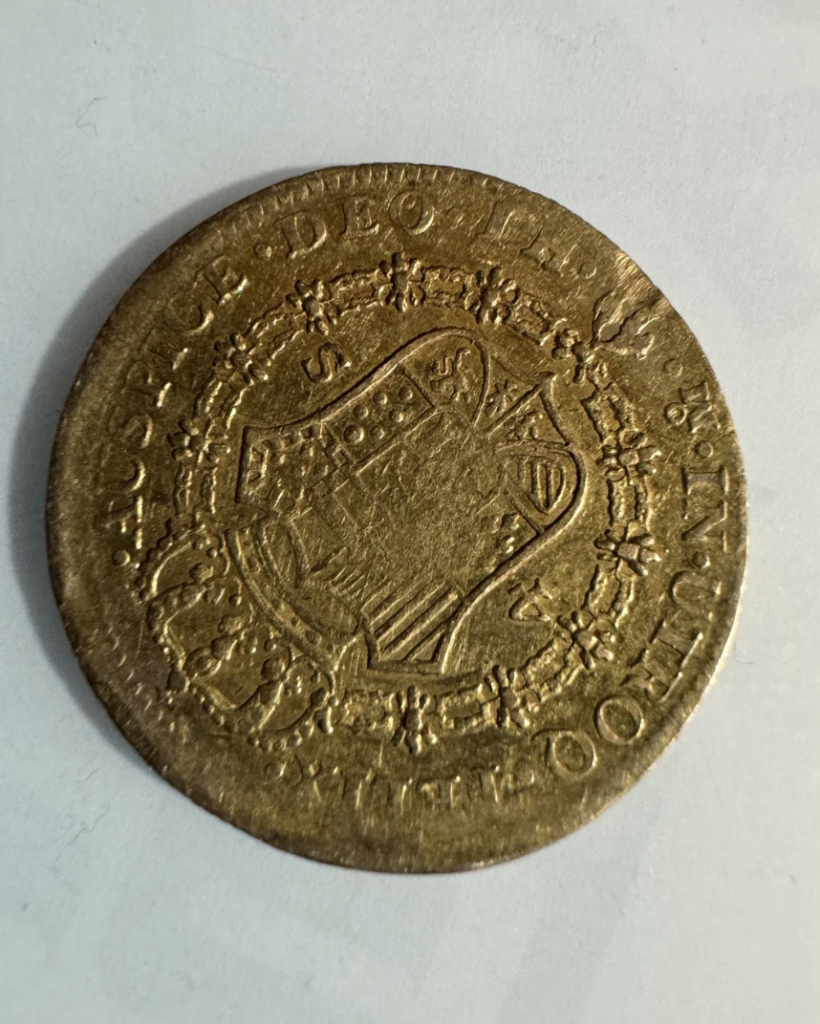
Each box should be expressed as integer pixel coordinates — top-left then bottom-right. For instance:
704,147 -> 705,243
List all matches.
48,165 -> 745,871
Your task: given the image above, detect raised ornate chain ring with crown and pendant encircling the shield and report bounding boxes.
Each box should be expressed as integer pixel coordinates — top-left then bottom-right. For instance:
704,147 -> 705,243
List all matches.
135,252 -> 660,755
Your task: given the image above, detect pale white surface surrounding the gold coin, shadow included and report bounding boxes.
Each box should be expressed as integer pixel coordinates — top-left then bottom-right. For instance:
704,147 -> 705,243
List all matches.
0,0 -> 820,1024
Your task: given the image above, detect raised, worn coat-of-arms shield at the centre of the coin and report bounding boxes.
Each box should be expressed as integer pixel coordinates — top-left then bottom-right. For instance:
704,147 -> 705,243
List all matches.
229,329 -> 584,674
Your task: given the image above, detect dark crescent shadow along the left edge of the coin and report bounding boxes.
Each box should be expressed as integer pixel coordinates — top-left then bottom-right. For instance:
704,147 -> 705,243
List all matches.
9,167 -> 316,771
